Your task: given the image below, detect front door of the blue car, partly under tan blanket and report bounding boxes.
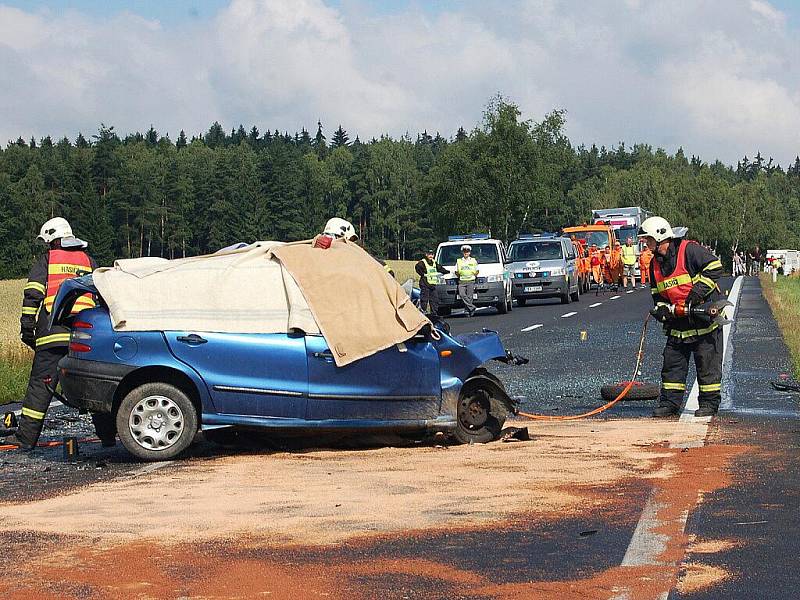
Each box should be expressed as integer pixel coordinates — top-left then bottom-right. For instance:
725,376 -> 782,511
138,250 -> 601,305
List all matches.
306,335 -> 441,420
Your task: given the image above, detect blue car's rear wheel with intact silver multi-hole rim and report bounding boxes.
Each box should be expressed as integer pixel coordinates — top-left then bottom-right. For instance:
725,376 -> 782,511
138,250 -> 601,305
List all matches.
116,382 -> 197,460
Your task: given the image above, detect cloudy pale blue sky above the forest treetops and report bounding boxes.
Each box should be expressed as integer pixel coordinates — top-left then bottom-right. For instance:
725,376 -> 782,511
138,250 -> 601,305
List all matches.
0,0 -> 800,166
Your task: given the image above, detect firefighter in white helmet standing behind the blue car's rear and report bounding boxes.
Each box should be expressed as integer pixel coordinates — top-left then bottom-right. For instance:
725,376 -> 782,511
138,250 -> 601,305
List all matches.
3,217 -> 116,450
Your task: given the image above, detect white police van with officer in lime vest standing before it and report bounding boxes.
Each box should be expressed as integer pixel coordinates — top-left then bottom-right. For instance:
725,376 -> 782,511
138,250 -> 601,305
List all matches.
436,233 -> 512,316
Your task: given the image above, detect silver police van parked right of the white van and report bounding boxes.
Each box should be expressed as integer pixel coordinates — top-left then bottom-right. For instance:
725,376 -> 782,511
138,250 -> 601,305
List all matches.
508,235 -> 580,306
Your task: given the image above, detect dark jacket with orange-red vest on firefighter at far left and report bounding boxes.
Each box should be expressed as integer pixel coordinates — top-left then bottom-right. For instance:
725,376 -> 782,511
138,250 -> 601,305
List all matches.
20,248 -> 97,350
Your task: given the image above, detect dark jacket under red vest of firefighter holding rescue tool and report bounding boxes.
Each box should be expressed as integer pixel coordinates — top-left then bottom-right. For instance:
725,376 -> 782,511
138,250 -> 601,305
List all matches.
650,239 -> 722,343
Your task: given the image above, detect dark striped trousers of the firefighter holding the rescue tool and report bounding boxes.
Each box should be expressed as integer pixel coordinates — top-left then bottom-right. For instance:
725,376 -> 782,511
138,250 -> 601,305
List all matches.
660,327 -> 723,410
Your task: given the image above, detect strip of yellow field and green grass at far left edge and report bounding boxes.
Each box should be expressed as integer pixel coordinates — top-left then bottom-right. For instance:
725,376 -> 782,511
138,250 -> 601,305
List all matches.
0,279 -> 33,404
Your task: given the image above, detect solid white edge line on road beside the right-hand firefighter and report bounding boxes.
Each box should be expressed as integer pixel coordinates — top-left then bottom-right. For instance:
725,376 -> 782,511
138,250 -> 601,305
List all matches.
615,277 -> 742,599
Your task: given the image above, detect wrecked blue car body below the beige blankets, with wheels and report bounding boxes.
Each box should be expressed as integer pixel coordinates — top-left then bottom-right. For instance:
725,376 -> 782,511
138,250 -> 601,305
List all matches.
52,275 -> 526,460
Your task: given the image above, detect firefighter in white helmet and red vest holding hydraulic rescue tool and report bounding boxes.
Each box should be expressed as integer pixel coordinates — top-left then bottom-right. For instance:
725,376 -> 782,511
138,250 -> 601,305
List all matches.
639,217 -> 723,417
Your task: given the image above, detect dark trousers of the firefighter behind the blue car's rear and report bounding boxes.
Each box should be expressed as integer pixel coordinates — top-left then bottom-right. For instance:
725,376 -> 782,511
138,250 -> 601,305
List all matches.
17,346 -> 116,446
